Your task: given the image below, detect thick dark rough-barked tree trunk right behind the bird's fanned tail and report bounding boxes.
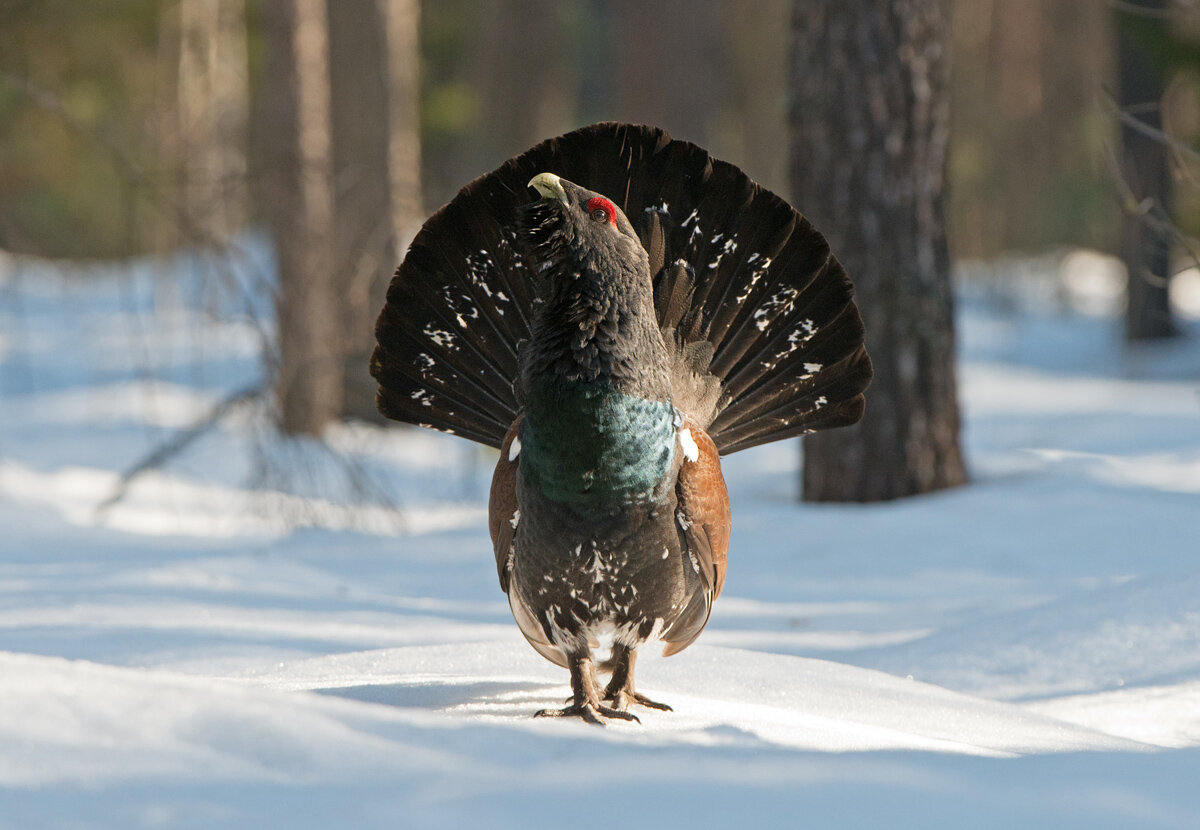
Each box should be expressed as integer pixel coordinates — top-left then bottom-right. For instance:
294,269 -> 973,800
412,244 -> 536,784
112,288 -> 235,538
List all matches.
790,0 -> 966,501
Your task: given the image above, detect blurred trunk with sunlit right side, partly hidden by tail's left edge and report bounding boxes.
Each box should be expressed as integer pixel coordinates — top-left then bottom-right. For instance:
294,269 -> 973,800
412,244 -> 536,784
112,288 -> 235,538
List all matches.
329,0 -> 421,420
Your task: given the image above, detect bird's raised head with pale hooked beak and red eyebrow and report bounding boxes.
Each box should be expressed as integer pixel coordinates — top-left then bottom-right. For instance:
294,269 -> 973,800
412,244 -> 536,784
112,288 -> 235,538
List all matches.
521,173 -> 648,284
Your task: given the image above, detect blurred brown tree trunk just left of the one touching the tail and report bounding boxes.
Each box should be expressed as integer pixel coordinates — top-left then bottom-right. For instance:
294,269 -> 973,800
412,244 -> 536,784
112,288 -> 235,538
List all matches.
263,0 -> 343,434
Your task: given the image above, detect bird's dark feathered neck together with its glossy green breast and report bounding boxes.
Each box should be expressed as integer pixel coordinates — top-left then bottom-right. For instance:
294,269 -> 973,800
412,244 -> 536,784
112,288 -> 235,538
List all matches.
521,201 -> 674,506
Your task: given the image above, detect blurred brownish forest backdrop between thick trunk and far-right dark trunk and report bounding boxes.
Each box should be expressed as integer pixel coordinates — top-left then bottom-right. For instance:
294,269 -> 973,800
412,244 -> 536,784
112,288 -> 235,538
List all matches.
947,0 -> 1117,258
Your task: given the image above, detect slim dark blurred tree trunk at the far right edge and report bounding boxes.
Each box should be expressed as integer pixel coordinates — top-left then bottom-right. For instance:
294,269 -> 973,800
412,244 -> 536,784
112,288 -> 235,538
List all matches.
1116,0 -> 1178,341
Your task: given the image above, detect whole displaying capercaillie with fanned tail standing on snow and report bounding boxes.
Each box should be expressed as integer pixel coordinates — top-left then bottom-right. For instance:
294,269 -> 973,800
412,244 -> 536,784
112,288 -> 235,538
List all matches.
371,124 -> 871,723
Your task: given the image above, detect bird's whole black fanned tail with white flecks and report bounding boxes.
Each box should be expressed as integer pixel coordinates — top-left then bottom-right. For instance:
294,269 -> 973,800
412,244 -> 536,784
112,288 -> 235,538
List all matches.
371,124 -> 871,453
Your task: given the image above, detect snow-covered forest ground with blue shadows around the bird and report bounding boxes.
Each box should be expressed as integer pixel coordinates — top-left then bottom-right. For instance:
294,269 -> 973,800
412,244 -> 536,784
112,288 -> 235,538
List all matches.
0,246 -> 1200,830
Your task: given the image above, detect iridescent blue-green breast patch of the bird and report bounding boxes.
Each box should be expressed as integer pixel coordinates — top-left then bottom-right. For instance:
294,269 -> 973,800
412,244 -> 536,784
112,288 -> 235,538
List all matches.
521,378 -> 676,505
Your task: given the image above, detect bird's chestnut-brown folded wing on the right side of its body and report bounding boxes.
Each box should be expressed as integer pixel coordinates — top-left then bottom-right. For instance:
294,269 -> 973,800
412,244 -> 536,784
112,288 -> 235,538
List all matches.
662,416 -> 730,656
